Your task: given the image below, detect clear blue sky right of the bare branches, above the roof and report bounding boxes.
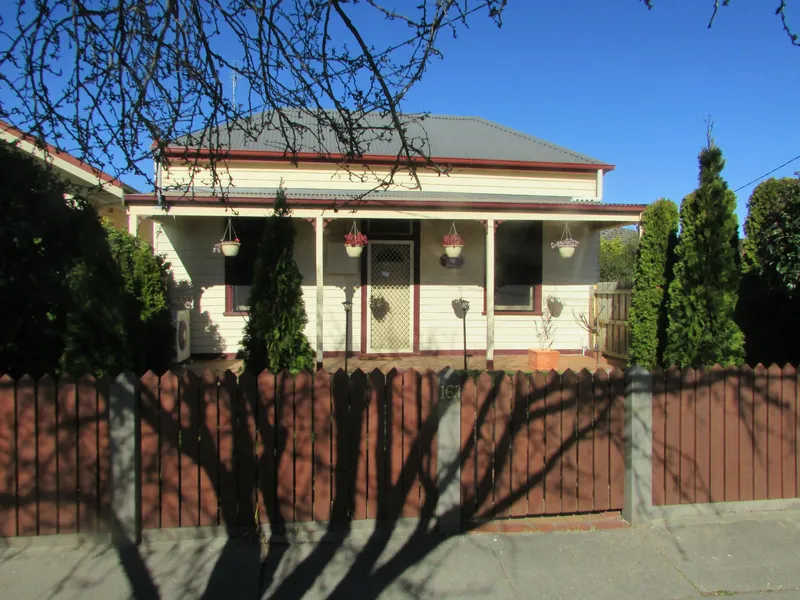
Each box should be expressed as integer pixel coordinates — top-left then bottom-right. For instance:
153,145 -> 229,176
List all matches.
396,0 -> 800,229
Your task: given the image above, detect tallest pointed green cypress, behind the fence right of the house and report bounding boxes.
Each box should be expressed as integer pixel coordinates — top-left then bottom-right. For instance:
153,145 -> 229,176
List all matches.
664,138 -> 744,367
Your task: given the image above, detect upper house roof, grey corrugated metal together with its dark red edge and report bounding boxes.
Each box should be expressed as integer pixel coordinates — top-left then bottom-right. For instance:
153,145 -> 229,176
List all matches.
162,111 -> 614,171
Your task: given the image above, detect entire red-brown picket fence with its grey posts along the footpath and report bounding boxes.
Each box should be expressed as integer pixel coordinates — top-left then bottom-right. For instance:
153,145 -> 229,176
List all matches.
0,365 -> 800,537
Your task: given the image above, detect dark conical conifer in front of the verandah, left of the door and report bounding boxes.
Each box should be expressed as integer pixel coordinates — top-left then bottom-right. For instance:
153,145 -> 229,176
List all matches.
242,187 -> 314,373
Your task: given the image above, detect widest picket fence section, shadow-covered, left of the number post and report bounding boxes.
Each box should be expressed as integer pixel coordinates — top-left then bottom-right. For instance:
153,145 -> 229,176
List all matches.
140,370 -> 437,529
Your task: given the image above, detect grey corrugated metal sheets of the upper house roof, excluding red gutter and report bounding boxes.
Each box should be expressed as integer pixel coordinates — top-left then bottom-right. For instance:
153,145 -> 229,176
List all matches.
175,110 -> 607,165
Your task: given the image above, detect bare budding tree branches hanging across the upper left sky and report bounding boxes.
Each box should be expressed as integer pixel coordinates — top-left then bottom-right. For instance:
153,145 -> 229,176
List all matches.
0,0 -> 800,204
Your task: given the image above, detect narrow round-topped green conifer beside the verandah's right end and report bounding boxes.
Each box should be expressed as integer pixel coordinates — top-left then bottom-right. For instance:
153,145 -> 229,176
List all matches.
629,198 -> 678,369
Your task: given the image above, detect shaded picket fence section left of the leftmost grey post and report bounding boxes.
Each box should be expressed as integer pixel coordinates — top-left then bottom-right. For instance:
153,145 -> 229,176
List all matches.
0,375 -> 109,537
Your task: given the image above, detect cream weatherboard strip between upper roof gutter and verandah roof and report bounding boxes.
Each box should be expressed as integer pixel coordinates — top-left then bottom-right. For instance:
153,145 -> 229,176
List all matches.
162,162 -> 598,198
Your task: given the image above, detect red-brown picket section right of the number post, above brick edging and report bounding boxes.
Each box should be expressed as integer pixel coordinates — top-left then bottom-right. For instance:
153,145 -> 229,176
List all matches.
461,369 -> 625,519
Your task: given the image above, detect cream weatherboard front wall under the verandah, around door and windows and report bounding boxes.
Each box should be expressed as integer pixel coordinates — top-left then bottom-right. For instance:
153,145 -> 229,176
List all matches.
154,216 -> 599,354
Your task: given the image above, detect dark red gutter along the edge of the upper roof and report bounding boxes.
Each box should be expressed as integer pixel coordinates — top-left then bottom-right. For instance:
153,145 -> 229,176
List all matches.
159,146 -> 615,172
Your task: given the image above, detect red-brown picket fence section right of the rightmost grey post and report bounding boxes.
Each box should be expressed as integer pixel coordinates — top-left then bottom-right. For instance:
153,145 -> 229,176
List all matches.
653,365 -> 800,505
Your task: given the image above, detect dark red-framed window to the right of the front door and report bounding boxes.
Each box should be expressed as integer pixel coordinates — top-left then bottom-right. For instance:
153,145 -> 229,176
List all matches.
494,221 -> 542,313
